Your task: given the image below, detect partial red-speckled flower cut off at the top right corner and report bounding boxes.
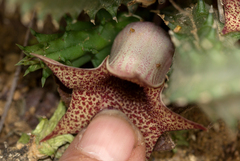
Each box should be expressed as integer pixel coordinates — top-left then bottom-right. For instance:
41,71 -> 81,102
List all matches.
222,0 -> 240,34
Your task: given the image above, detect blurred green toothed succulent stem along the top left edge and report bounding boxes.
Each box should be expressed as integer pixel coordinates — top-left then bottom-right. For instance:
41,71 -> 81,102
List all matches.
3,0 -> 155,28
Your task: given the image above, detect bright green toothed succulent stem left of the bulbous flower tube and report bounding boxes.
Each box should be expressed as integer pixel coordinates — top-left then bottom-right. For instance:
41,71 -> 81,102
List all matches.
18,10 -> 139,85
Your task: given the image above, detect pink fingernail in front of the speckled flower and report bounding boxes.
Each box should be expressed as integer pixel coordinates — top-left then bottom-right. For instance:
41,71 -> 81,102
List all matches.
77,110 -> 137,161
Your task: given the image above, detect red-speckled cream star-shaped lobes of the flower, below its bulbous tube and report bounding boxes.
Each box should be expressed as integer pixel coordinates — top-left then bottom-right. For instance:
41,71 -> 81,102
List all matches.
32,54 -> 205,158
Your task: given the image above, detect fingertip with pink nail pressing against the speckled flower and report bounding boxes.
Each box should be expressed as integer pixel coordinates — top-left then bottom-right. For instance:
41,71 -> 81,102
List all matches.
60,110 -> 145,161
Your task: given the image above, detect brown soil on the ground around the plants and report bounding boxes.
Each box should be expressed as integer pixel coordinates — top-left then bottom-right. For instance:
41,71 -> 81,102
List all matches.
0,1 -> 240,161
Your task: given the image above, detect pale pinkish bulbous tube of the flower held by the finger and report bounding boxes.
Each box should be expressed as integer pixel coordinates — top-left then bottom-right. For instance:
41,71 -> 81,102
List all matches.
107,22 -> 174,87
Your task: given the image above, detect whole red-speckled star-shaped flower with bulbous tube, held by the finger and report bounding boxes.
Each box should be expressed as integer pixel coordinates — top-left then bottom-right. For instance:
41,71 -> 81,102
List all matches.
32,22 -> 205,158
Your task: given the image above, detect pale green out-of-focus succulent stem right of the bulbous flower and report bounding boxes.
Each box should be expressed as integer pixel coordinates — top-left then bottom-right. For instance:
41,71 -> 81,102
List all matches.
159,0 -> 240,127
